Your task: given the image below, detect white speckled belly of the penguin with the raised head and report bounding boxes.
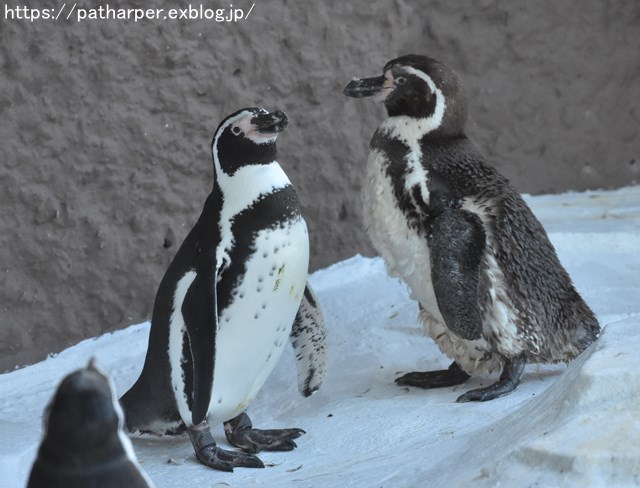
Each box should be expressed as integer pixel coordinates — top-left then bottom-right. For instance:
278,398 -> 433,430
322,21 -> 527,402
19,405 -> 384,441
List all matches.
209,219 -> 309,422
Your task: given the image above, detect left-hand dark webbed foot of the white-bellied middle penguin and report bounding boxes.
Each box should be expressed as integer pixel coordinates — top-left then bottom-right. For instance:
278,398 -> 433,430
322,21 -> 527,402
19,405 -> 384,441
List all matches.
188,420 -> 264,472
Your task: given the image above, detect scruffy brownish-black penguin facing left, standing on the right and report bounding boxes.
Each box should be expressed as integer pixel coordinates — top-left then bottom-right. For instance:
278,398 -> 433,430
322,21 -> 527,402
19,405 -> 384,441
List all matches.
343,54 -> 600,402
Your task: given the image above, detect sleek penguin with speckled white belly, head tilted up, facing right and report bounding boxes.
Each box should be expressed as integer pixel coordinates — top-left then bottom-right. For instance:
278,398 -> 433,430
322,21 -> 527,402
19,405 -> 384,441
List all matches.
121,107 -> 326,471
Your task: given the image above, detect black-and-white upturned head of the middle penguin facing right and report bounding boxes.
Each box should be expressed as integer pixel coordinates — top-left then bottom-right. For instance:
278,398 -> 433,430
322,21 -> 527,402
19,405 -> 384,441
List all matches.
211,107 -> 288,176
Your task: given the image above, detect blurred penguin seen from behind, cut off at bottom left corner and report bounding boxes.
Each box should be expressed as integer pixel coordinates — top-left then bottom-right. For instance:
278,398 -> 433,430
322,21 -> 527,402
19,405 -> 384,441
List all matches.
27,360 -> 153,488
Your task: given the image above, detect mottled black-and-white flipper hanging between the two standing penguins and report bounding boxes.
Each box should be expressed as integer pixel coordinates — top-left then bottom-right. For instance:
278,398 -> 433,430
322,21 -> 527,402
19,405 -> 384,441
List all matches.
289,283 -> 327,397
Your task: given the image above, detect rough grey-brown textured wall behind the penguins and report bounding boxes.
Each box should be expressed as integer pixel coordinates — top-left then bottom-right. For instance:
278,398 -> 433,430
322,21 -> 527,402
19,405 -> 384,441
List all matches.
0,0 -> 640,371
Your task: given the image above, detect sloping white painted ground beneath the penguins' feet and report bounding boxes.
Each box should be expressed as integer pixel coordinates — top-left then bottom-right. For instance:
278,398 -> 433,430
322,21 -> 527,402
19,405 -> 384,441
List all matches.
0,187 -> 640,488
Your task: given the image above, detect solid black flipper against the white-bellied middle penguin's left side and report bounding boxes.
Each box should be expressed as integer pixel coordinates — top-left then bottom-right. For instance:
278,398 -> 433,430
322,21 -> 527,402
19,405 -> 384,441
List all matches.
182,273 -> 218,424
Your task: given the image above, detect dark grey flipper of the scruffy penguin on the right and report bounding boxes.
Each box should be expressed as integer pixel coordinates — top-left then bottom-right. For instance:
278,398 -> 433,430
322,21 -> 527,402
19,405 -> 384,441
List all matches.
430,208 -> 486,340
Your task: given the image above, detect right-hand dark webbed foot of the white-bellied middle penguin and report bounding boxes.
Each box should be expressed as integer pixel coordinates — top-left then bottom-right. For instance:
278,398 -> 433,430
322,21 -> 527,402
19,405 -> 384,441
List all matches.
224,413 -> 305,453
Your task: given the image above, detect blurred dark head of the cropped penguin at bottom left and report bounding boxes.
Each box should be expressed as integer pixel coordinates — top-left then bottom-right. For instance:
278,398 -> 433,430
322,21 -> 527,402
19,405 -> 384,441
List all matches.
43,361 -> 123,459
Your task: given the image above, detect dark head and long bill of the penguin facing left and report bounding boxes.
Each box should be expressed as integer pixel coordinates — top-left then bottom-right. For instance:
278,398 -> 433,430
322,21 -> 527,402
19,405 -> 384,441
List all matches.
343,54 -> 467,136
